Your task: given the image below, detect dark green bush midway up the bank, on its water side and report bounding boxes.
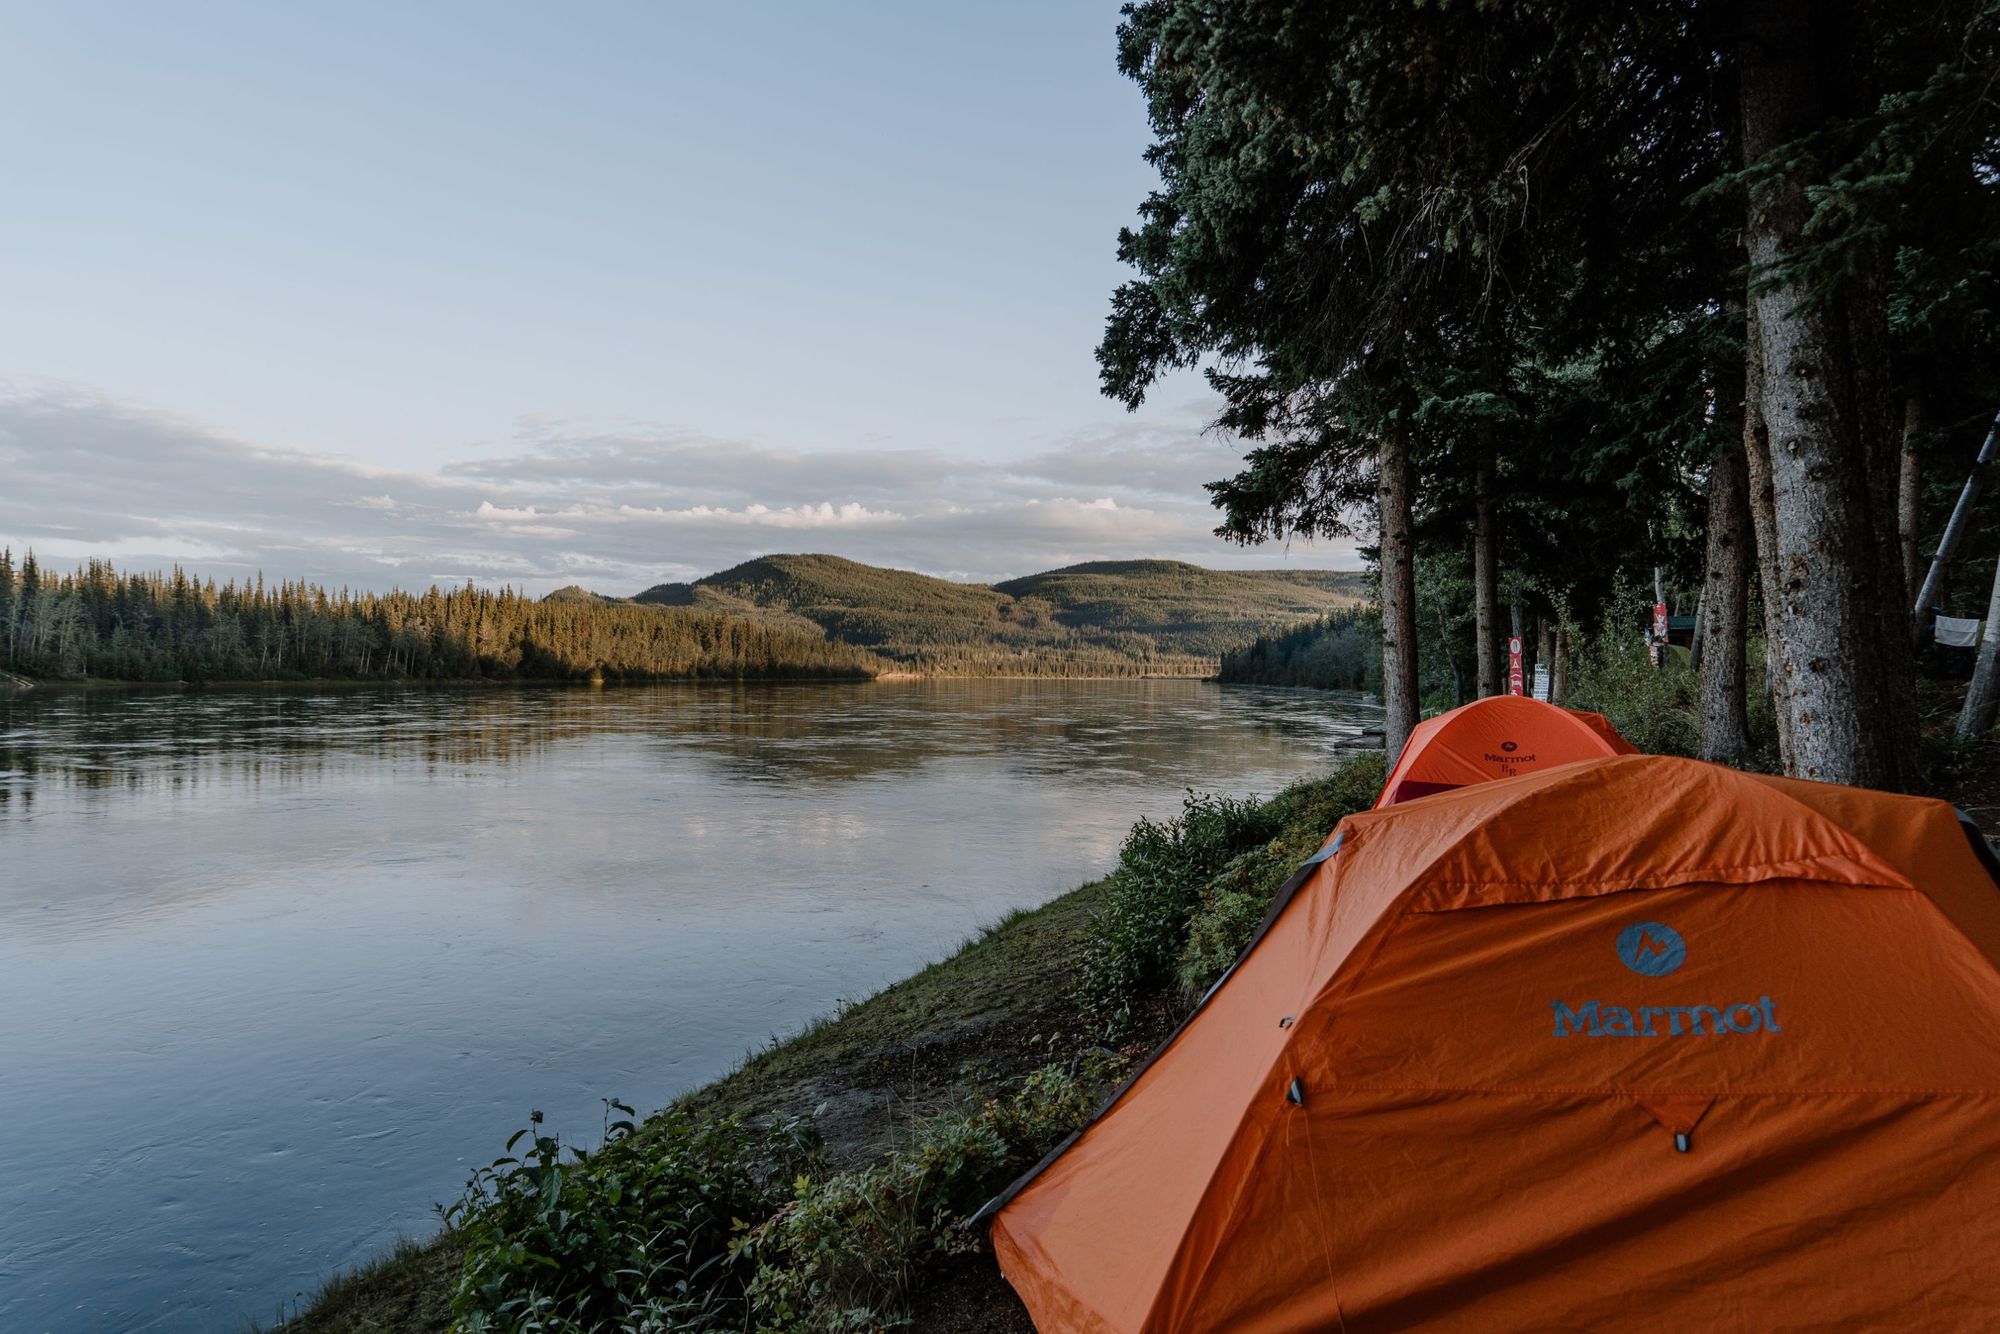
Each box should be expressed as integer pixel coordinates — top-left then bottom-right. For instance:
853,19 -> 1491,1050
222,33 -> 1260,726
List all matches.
1082,792 -> 1282,1030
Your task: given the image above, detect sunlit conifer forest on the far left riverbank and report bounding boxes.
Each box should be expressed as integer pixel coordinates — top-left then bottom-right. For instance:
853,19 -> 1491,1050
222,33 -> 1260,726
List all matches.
0,552 -> 886,682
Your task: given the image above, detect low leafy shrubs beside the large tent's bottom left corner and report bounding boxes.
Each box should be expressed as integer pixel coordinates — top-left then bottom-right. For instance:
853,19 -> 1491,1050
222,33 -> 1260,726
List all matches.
736,1062 -> 1112,1334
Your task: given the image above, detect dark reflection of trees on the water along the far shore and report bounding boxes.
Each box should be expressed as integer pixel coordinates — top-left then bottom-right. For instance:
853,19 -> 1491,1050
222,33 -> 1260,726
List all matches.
0,680 -> 1374,814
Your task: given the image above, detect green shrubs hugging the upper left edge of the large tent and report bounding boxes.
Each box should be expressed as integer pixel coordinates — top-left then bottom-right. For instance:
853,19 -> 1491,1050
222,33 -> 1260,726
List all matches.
1174,750 -> 1384,996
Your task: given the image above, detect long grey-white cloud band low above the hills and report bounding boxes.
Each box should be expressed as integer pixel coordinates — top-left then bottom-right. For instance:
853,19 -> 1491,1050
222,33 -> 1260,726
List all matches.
0,386 -> 1360,594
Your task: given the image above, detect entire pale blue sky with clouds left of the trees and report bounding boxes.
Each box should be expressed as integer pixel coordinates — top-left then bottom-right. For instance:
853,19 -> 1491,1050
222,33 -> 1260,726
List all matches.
0,0 -> 1360,594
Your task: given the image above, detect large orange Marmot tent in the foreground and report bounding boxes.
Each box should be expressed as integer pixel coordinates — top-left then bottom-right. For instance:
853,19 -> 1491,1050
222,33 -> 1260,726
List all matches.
988,756 -> 2000,1334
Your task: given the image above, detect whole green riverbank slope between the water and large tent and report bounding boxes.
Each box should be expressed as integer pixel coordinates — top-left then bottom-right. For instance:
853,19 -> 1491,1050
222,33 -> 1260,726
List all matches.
284,754 -> 1382,1334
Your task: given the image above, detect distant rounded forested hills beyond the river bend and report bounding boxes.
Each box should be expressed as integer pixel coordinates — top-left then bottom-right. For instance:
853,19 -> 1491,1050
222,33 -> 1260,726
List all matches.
548,554 -> 1366,676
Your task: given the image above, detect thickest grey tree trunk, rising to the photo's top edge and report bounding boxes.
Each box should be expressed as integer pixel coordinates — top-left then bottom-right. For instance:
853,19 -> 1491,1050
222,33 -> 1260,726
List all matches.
1740,0 -> 1916,788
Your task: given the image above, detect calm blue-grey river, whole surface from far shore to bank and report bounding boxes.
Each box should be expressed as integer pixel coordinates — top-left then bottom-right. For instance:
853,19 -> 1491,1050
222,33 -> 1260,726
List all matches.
0,680 -> 1378,1330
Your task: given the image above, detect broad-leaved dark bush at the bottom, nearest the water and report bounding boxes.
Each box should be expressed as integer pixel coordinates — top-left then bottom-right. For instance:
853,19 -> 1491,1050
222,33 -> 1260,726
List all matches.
446,1102 -> 816,1334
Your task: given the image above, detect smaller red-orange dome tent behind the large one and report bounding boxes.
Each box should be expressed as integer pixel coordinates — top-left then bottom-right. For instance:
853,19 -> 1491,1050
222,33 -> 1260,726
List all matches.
1376,694 -> 1638,806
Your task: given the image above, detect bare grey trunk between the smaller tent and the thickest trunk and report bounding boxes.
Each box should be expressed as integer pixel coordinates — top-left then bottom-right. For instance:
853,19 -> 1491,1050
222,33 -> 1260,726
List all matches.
1700,448 -> 1752,764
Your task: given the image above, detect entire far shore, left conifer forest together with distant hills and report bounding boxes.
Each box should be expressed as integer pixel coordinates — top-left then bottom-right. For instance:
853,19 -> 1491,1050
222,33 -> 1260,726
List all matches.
0,552 -> 1362,688
